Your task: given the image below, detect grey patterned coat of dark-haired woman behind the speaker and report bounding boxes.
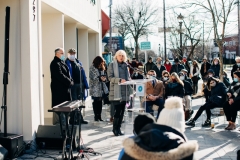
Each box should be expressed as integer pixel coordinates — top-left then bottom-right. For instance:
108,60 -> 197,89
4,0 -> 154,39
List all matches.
89,65 -> 108,97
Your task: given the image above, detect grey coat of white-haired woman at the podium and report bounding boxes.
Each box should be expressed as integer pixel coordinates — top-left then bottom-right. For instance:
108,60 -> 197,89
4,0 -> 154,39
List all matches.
108,61 -> 132,101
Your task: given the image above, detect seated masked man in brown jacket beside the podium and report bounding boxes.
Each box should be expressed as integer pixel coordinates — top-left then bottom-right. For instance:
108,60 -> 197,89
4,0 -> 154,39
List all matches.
143,70 -> 164,118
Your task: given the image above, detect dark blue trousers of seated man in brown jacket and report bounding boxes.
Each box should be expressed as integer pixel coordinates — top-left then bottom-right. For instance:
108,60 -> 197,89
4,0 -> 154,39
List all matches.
143,98 -> 164,118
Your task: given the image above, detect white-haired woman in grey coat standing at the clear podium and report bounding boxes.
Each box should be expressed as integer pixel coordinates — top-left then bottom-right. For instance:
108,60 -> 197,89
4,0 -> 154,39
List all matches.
108,50 -> 131,136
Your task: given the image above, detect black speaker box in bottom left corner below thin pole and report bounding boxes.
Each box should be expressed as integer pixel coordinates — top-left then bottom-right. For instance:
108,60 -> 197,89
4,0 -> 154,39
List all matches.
0,133 -> 24,159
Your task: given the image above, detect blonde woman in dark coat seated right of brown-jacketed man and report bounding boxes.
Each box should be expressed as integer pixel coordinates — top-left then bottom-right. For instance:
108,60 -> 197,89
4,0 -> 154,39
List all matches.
165,72 -> 184,98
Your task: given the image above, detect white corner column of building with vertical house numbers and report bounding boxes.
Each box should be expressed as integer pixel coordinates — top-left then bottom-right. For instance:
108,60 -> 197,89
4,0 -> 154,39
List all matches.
19,0 -> 41,140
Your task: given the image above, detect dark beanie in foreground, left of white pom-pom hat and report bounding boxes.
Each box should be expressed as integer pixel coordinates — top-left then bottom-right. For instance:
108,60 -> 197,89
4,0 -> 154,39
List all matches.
133,113 -> 156,135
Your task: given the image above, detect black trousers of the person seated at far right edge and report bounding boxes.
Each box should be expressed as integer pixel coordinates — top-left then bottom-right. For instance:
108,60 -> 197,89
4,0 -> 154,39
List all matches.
223,101 -> 240,123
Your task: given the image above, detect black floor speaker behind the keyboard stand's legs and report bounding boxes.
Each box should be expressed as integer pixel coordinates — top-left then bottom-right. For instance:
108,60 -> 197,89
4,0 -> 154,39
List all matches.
36,125 -> 78,150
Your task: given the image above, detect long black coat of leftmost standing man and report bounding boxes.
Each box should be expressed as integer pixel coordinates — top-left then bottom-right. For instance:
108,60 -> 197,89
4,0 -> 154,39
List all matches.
50,56 -> 72,107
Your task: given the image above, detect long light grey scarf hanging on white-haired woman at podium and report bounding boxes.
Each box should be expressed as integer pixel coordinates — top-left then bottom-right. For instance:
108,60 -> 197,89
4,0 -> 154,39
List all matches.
113,60 -> 122,101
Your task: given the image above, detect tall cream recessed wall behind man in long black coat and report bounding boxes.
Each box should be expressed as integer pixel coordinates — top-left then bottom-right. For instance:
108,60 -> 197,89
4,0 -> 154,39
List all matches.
42,13 -> 64,122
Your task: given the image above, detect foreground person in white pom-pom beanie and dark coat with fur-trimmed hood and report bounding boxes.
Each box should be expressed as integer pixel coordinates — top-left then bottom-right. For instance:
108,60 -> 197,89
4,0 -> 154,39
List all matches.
120,97 -> 198,160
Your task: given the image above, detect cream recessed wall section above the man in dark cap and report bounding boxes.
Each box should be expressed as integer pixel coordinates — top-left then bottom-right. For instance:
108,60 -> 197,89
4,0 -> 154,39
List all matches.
64,23 -> 77,52
